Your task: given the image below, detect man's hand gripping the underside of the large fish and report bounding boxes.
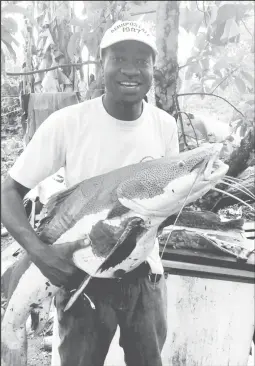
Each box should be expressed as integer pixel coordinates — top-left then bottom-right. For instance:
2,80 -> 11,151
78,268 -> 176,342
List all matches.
30,240 -> 88,290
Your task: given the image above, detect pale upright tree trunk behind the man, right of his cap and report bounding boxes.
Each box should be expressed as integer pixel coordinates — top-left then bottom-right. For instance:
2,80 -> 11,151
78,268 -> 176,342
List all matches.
155,1 -> 179,116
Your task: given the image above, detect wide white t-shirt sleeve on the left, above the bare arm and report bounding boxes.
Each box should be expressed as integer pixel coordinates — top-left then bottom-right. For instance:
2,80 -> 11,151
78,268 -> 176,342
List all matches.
9,110 -> 66,189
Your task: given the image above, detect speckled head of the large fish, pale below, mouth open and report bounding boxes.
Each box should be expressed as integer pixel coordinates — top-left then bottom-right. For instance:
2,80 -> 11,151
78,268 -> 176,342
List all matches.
117,143 -> 228,217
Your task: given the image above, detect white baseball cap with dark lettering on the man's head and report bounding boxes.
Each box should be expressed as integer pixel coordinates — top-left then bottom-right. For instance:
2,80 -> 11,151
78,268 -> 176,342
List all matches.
100,20 -> 158,58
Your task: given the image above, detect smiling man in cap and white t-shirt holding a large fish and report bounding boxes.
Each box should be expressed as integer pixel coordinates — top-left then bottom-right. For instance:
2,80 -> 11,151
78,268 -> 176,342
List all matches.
2,22 -> 178,366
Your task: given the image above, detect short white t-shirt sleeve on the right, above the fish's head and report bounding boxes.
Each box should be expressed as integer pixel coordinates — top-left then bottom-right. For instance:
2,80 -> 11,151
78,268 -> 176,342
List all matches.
164,115 -> 179,156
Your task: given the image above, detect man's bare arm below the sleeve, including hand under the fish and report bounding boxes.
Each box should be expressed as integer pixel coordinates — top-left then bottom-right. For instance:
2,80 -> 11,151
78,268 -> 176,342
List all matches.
1,176 -> 84,288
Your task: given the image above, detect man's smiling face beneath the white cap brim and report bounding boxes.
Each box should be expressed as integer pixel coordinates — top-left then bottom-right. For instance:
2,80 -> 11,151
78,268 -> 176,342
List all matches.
103,41 -> 153,103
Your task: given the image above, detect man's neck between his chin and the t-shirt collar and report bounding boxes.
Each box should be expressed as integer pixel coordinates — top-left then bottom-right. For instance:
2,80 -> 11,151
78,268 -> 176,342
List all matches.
103,94 -> 143,121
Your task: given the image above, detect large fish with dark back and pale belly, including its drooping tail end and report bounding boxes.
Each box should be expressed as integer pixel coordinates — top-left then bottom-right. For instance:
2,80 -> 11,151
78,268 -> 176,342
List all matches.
2,144 -> 228,366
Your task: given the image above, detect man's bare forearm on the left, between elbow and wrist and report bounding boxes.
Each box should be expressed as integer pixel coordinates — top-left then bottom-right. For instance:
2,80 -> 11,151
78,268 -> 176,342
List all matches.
1,183 -> 43,254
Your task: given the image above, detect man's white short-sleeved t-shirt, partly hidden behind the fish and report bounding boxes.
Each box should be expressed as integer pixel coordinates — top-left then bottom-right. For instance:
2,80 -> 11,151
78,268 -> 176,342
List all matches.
9,96 -> 179,273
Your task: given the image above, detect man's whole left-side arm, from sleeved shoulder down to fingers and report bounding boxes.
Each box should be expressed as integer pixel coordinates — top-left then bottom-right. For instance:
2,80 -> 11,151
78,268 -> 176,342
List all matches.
2,109 -> 84,286
